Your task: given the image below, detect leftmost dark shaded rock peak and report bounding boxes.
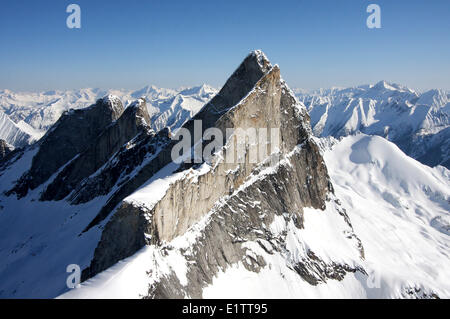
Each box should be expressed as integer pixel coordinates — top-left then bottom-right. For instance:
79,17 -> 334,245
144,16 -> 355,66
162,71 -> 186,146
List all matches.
9,96 -> 123,197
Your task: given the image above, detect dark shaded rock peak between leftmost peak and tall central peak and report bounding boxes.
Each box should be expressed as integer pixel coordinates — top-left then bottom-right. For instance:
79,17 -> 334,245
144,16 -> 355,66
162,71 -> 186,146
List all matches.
41,99 -> 154,200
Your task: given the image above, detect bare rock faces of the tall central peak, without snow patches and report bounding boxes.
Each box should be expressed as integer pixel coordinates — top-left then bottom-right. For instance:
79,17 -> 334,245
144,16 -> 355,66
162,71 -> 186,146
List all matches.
83,53 -> 363,298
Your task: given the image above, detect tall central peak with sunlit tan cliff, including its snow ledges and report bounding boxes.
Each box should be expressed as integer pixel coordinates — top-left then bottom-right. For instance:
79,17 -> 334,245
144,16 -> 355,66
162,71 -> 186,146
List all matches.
83,51 -> 363,298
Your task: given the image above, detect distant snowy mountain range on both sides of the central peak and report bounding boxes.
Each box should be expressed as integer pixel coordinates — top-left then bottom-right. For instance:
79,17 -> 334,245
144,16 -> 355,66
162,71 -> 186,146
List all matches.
0,81 -> 450,168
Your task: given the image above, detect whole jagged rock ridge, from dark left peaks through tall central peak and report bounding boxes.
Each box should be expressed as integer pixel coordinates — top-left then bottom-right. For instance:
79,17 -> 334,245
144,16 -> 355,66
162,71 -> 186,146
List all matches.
0,51 -> 365,298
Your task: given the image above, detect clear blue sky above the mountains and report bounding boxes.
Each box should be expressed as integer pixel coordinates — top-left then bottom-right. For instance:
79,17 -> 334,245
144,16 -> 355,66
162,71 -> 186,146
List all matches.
0,0 -> 450,91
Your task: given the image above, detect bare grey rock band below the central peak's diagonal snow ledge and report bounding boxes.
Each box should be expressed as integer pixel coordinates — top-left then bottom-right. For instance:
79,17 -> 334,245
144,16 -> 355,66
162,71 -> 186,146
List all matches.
148,146 -> 358,299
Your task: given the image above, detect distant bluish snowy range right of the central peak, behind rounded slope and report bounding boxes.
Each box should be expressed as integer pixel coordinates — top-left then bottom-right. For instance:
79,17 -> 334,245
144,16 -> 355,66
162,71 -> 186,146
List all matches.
297,81 -> 450,168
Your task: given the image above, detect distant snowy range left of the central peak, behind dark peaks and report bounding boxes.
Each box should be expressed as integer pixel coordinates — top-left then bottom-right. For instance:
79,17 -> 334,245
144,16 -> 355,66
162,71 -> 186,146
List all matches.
0,84 -> 217,147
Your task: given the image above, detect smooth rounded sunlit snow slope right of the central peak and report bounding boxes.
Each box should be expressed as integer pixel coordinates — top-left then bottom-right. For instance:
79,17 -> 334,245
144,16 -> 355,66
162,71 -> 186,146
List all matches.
325,134 -> 450,298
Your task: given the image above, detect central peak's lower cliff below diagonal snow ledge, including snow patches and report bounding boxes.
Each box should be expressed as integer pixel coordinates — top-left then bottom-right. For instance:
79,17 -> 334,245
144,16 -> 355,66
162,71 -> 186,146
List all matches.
146,150 -> 364,298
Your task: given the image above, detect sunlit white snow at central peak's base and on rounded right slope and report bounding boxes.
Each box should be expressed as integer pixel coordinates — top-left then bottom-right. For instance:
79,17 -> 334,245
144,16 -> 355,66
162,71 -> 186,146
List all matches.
61,134 -> 450,298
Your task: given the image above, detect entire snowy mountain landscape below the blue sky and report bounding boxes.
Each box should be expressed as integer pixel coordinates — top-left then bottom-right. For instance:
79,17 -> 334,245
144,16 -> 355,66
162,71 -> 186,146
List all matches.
0,51 -> 450,300
